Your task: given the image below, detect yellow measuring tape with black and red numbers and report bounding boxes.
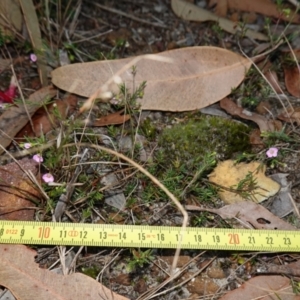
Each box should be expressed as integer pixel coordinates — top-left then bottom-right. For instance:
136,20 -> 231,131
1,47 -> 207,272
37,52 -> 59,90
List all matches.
0,221 -> 300,252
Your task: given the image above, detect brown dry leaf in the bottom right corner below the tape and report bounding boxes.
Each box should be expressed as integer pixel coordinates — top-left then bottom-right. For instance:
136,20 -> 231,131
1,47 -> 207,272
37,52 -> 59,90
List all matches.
220,276 -> 300,300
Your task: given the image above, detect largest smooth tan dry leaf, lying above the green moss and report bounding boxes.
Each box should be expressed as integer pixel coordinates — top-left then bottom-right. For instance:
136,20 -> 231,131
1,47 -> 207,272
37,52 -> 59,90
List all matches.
52,47 -> 251,111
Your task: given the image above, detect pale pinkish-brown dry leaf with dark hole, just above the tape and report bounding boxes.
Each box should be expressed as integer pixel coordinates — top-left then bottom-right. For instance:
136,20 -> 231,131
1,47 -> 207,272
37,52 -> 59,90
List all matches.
185,201 -> 297,230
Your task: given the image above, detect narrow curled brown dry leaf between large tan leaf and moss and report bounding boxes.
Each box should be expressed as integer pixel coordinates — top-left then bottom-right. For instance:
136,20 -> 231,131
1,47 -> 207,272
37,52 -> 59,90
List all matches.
220,98 -> 282,131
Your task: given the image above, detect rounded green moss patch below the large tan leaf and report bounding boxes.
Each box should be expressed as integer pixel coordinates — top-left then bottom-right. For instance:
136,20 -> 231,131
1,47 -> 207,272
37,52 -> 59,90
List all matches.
159,115 -> 251,168
